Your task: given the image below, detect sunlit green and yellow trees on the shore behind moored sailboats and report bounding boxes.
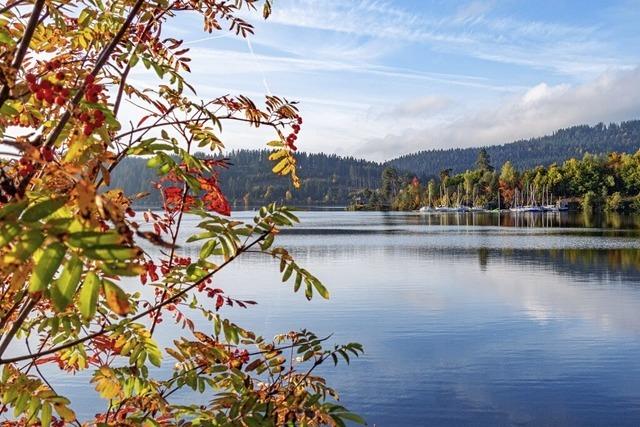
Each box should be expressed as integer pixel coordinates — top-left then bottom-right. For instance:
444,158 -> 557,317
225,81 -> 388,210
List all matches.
351,148 -> 640,211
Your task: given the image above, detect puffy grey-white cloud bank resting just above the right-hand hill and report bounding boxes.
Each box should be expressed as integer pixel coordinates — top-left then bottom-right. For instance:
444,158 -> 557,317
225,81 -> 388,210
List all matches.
356,67 -> 640,159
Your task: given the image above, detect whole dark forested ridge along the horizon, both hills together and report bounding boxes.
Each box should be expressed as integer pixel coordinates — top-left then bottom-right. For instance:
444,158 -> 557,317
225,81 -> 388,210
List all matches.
111,120 -> 640,209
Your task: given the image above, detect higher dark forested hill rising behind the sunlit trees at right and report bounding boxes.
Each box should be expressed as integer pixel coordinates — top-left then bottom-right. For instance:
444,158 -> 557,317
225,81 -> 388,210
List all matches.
387,120 -> 640,177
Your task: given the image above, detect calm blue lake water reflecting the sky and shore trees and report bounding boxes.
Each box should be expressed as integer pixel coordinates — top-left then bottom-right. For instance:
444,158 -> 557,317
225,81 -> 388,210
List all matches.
47,211 -> 640,426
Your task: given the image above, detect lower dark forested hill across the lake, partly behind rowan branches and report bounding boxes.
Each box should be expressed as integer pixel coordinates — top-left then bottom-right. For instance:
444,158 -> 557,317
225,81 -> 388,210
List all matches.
111,150 -> 383,209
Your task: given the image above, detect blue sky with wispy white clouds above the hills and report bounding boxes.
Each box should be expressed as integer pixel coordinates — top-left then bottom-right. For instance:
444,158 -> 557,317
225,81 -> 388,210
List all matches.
155,0 -> 640,161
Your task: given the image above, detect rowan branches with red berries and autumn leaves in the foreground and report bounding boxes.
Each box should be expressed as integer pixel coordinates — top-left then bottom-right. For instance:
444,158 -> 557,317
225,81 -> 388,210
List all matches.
0,0 -> 362,426
